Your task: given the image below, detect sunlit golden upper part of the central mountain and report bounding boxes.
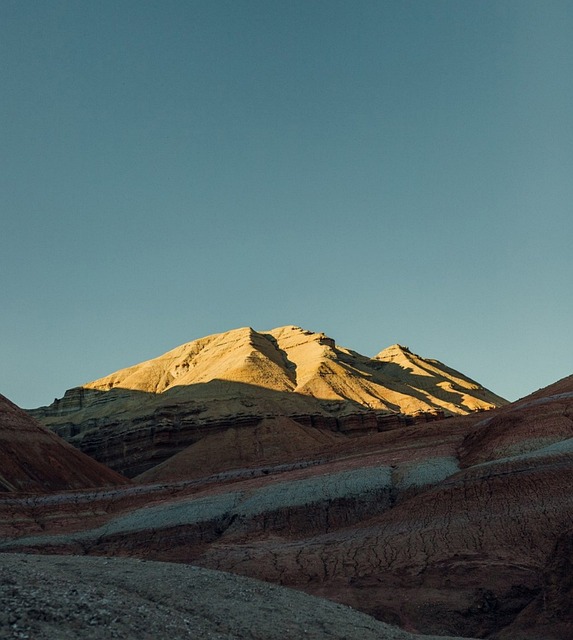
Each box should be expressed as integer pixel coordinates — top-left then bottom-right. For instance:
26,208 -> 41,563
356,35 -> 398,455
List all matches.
79,326 -> 504,414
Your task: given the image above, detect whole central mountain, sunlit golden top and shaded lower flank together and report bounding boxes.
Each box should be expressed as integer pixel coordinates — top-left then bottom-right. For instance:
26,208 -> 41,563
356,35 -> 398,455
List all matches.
30,326 -> 505,477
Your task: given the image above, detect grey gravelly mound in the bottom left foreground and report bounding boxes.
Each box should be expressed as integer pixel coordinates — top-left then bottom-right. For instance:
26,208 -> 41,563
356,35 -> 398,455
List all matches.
0,554 -> 474,640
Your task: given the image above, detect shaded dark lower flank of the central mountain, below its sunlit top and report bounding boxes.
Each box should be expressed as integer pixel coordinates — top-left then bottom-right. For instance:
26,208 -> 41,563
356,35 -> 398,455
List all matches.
29,379 -> 438,477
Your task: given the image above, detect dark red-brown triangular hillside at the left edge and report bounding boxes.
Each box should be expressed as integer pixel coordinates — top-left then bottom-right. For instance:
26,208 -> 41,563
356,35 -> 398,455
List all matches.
0,395 -> 128,493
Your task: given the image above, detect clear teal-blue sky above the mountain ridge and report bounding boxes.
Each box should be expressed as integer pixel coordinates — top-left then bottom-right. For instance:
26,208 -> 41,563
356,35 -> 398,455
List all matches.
0,0 -> 573,407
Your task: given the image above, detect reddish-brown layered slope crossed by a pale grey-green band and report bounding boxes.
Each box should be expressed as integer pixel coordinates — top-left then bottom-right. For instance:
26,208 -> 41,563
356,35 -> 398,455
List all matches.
5,378 -> 573,640
